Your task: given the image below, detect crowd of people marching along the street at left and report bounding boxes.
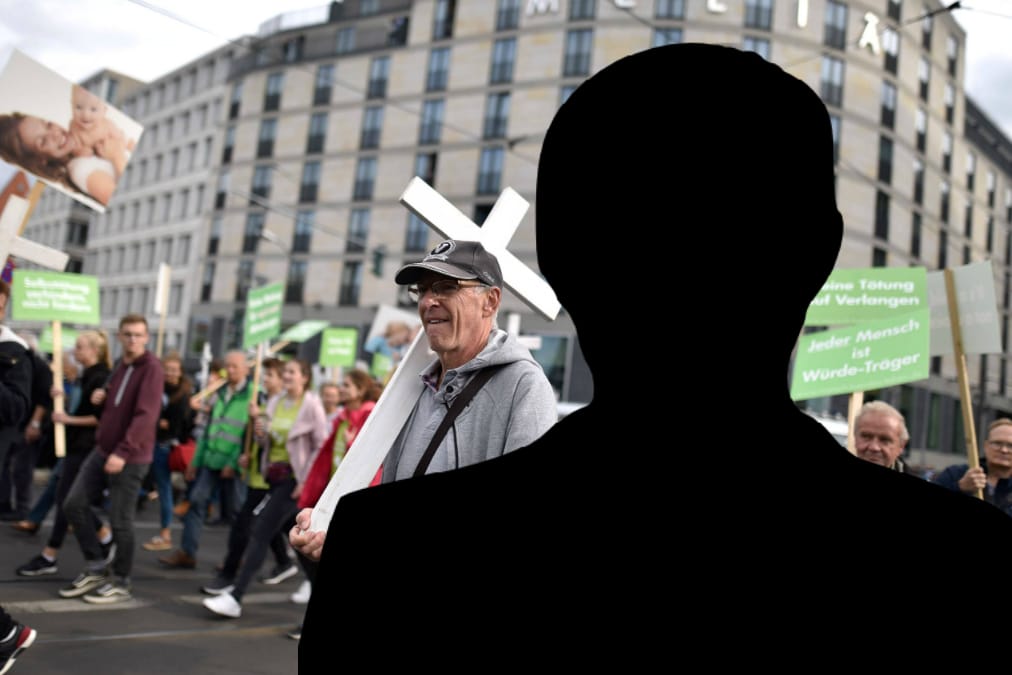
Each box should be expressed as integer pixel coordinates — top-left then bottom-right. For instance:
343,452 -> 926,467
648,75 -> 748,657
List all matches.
0,284 -> 394,667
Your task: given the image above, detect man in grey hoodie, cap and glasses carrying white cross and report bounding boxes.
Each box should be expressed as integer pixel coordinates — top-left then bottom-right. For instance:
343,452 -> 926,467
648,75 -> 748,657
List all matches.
383,240 -> 558,483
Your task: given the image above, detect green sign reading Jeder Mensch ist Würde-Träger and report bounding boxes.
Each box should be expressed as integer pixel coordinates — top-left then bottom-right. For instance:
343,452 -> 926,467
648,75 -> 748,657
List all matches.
790,308 -> 931,401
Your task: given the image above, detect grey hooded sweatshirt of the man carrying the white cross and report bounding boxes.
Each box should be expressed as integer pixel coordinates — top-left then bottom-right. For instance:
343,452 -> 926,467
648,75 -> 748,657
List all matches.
383,329 -> 559,483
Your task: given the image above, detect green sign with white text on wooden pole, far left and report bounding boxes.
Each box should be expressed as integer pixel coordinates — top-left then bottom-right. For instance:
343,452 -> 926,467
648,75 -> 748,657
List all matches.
10,269 -> 98,326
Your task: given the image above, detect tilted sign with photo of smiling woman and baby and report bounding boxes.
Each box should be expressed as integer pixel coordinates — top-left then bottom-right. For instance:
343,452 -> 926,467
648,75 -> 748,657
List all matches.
0,51 -> 144,213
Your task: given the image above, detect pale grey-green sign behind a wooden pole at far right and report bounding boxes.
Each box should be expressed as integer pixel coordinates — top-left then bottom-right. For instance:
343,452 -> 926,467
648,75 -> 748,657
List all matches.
928,260 -> 1002,356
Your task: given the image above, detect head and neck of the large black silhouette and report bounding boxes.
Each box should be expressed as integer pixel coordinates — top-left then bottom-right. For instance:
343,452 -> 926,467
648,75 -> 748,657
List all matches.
536,44 -> 843,392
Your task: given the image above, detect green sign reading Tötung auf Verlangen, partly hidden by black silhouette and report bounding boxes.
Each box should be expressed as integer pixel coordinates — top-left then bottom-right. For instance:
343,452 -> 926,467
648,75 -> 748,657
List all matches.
805,267 -> 928,326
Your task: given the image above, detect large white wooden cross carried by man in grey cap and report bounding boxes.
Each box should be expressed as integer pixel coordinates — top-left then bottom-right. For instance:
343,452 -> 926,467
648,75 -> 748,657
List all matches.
310,176 -> 561,531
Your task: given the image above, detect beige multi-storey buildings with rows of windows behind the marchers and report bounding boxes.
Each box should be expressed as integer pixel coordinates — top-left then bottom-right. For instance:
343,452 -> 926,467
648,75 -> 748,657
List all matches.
13,0 -> 1012,465
